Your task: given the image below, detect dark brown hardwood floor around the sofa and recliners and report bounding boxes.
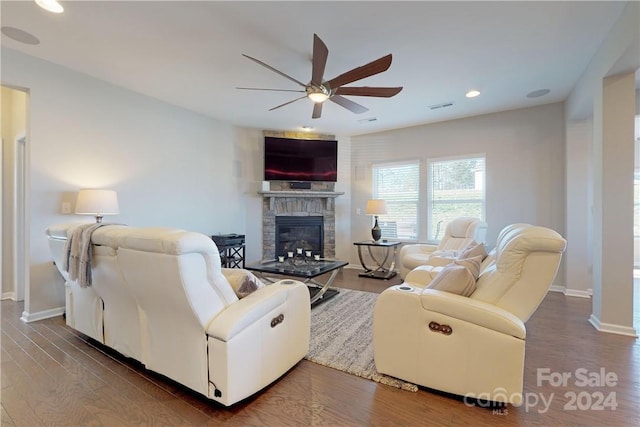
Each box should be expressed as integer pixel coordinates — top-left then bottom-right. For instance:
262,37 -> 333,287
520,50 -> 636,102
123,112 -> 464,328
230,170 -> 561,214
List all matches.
0,269 -> 640,426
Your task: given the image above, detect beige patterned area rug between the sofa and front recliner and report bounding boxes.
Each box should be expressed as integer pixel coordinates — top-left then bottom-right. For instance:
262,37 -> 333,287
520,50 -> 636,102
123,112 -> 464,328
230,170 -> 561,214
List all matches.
306,289 -> 418,392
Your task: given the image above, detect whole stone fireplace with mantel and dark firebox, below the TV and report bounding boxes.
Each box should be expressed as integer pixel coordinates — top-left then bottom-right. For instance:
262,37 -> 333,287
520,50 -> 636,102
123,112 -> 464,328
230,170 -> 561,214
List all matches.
259,183 -> 344,260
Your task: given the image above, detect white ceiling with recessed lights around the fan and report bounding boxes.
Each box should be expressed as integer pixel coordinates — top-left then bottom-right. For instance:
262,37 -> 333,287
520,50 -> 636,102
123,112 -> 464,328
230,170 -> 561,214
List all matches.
0,1 -> 625,135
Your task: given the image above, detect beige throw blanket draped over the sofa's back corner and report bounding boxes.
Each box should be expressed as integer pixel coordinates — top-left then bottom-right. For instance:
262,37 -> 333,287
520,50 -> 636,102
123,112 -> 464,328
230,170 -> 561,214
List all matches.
62,223 -> 107,288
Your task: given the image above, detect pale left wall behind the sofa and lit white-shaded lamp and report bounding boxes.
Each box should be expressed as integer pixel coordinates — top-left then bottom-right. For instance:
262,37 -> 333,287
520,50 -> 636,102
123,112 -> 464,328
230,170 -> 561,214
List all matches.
2,48 -> 254,319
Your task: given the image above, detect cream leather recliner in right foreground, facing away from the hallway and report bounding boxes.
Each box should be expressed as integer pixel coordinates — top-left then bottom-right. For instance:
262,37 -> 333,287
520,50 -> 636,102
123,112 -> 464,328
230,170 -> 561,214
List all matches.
373,224 -> 566,404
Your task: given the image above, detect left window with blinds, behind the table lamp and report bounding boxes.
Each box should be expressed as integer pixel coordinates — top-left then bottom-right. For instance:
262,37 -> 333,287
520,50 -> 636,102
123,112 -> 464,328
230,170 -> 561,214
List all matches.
373,160 -> 420,240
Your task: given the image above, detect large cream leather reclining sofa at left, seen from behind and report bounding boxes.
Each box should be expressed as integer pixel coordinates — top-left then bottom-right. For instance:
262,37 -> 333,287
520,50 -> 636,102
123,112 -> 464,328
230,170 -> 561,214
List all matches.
47,224 -> 310,406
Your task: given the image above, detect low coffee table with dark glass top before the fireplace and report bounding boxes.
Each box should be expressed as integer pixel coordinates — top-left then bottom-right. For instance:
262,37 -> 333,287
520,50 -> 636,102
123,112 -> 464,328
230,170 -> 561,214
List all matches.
245,259 -> 349,306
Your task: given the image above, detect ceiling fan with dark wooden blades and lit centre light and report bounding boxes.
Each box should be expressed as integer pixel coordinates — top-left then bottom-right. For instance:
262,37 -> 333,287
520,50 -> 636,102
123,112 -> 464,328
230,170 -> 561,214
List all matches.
237,34 -> 402,119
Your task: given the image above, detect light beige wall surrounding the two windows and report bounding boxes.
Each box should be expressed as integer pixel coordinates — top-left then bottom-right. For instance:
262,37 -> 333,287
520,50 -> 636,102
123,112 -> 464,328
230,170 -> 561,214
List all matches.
351,104 -> 564,272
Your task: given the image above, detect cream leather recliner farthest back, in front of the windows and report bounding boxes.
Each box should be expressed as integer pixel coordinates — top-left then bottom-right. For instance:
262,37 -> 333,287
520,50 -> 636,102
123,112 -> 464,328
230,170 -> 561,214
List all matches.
399,217 -> 487,278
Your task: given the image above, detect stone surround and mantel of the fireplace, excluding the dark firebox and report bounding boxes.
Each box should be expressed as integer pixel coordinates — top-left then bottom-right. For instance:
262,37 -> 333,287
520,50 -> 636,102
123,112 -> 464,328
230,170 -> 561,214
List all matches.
258,181 -> 344,260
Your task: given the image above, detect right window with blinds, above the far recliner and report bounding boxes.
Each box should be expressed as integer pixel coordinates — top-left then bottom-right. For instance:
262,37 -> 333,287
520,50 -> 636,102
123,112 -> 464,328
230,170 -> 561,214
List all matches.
427,156 -> 485,240
